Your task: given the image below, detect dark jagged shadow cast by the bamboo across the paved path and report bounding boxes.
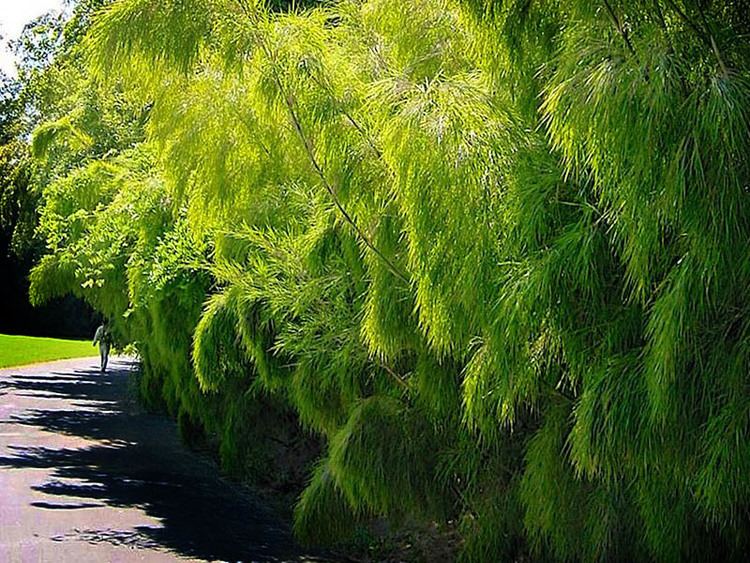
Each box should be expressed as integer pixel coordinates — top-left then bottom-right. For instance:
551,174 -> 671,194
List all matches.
0,363 -> 328,561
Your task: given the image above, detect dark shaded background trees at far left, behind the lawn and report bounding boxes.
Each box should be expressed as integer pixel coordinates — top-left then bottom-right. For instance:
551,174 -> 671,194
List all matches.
0,11 -> 95,337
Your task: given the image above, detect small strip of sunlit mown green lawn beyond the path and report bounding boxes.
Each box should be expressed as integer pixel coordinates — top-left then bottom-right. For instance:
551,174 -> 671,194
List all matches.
0,334 -> 99,368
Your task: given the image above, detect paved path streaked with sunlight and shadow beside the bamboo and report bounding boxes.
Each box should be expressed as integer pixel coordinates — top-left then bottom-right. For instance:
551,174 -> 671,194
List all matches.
0,358 -> 328,563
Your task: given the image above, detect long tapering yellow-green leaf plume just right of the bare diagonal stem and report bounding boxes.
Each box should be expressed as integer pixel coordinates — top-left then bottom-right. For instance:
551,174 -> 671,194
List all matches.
372,71 -> 510,355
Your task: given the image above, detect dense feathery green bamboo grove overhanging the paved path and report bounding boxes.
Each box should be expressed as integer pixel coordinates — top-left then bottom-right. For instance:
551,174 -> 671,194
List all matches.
26,0 -> 750,561
